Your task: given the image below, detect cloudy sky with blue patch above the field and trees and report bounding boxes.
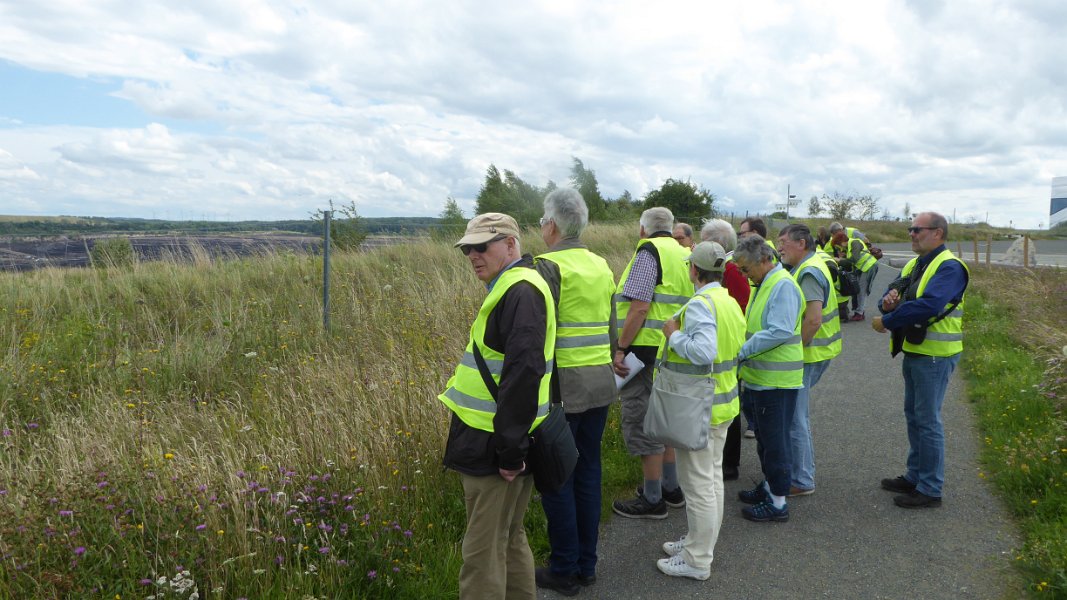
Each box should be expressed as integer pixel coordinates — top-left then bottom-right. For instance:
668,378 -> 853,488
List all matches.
0,0 -> 1067,227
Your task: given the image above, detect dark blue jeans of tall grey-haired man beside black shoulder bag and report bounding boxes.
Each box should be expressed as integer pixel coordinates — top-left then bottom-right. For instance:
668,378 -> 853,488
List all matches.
541,407 -> 608,577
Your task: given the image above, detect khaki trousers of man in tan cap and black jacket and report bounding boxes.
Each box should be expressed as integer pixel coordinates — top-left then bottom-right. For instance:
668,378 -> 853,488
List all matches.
460,473 -> 537,600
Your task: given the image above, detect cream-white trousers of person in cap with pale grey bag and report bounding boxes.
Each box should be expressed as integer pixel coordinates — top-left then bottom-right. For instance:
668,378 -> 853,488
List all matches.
674,421 -> 730,569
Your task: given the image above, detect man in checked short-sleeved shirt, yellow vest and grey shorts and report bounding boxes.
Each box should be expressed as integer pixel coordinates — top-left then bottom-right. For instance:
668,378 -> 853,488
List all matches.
611,206 -> 694,519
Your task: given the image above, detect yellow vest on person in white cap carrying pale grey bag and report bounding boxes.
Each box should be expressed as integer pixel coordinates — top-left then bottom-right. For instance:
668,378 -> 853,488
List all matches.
660,286 -> 745,425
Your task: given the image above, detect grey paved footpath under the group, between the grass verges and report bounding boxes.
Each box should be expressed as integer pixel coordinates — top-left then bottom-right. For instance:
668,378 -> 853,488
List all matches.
539,265 -> 1022,600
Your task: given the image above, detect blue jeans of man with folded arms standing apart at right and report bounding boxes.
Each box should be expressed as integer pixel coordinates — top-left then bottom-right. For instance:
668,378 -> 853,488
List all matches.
903,354 -> 959,498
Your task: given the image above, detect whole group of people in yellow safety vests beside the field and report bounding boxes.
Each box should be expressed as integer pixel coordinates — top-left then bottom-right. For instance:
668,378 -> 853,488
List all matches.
431,189 -> 967,599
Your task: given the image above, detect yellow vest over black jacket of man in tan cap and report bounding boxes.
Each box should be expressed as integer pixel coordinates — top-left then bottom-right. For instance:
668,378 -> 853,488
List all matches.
437,267 -> 556,432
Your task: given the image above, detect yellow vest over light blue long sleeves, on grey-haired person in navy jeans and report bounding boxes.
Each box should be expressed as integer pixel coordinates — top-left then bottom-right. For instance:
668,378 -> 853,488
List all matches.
740,269 -> 803,389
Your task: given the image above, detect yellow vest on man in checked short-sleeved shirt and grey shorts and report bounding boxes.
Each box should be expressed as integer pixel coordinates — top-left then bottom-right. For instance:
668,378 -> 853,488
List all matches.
615,237 -> 694,348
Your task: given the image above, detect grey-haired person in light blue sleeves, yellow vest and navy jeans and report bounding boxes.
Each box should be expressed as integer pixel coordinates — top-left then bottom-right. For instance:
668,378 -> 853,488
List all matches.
734,234 -> 803,522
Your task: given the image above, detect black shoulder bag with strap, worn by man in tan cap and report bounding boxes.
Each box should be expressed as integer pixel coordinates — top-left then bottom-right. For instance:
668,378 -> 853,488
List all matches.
472,342 -> 578,493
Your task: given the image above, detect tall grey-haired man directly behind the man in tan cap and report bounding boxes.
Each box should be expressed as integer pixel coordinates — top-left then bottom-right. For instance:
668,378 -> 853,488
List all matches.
536,188 -> 618,596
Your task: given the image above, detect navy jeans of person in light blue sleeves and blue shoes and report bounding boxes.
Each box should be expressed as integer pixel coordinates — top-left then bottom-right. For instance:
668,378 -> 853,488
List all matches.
743,388 -> 797,495
